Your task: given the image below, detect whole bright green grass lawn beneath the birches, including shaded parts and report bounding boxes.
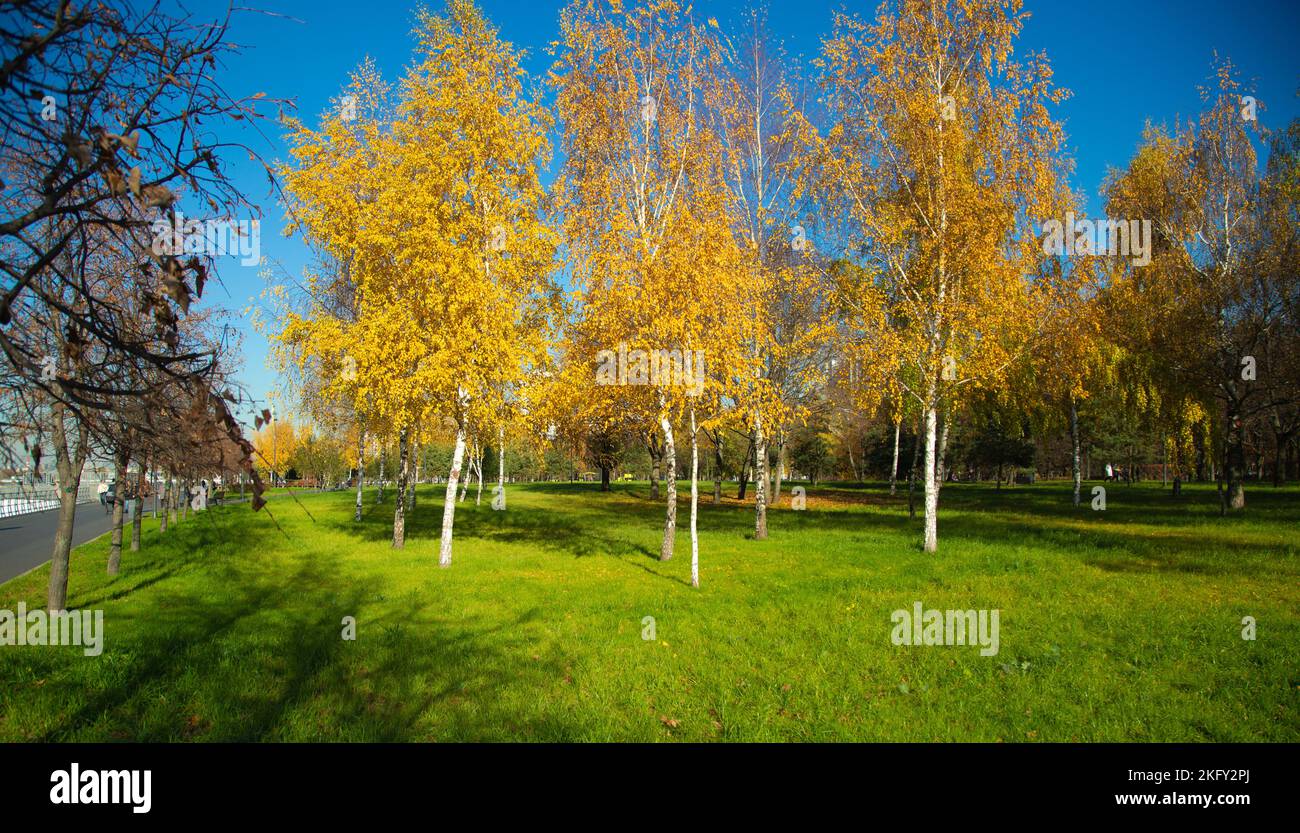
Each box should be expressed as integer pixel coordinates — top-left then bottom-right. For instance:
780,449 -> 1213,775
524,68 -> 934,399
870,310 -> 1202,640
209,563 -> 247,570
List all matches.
0,483 -> 1300,742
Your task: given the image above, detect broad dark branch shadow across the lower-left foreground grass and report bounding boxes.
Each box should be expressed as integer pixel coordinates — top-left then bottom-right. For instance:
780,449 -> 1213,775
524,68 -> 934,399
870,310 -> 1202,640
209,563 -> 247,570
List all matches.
0,499 -> 581,741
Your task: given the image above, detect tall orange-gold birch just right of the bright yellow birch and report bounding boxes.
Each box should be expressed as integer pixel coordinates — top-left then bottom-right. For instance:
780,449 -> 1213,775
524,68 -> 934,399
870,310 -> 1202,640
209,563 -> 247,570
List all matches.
550,0 -> 743,560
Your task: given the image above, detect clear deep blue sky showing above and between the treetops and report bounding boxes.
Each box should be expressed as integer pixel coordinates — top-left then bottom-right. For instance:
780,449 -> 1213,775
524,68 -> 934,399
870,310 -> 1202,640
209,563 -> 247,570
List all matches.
186,0 -> 1300,413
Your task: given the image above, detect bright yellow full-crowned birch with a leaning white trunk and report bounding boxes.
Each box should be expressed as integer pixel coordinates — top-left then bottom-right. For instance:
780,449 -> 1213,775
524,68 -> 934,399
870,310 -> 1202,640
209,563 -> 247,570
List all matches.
278,0 -> 553,567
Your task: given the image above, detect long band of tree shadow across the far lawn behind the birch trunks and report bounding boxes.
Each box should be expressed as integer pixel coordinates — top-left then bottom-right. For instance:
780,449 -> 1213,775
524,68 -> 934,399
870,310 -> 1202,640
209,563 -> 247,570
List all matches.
332,483 -> 1300,581
